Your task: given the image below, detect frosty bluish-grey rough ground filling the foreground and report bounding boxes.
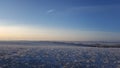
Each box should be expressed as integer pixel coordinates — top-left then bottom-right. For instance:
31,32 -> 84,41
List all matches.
0,45 -> 120,68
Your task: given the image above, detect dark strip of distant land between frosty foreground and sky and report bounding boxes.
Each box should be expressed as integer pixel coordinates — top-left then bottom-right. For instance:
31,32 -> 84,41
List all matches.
0,41 -> 120,48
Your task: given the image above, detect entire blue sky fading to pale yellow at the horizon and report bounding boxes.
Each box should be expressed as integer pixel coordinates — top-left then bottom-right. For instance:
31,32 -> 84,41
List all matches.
0,0 -> 120,41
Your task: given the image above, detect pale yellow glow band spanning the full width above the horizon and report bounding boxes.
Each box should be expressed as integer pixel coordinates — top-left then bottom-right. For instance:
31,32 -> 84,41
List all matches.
0,26 -> 120,41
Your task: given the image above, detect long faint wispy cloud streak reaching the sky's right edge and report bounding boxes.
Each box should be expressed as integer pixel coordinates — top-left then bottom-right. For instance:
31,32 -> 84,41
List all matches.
62,5 -> 120,14
